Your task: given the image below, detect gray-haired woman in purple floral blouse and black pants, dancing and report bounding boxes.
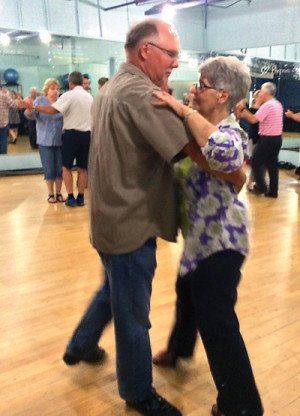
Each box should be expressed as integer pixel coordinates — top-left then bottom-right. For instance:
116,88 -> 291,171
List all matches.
154,57 -> 263,416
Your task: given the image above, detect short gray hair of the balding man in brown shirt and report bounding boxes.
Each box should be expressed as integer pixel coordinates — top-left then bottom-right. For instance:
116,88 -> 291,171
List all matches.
125,19 -> 161,51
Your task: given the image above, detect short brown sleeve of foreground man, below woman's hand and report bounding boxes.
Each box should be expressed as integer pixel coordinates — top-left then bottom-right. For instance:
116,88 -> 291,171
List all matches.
129,91 -> 191,163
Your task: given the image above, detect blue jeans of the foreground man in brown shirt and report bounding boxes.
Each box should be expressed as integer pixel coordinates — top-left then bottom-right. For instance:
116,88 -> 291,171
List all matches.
67,238 -> 156,402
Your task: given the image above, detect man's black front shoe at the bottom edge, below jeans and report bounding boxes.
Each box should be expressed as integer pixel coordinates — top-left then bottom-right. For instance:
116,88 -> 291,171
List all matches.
126,389 -> 182,416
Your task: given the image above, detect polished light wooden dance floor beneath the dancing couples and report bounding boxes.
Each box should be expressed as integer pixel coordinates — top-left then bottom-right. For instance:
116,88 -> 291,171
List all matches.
0,172 -> 300,416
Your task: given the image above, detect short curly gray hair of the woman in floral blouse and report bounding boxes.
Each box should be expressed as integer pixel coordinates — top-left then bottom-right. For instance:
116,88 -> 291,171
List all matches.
199,56 -> 251,111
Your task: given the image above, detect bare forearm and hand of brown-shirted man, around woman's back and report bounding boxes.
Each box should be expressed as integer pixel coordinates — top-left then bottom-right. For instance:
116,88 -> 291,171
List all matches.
182,140 -> 246,192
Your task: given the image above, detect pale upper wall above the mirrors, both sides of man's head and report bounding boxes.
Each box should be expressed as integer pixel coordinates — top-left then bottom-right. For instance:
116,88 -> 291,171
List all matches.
0,0 -> 300,51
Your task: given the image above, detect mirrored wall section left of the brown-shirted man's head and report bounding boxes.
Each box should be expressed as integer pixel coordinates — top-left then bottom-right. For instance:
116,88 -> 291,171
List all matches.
0,31 -> 124,161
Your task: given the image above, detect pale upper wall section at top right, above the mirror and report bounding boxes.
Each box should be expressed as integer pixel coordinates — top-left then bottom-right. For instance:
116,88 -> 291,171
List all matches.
207,0 -> 300,51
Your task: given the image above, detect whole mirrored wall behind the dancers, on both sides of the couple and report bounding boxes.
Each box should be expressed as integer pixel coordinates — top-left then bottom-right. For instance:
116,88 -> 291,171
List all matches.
0,29 -> 300,171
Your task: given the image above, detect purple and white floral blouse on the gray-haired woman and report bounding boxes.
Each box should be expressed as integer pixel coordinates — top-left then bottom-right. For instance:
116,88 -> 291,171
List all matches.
179,114 -> 249,275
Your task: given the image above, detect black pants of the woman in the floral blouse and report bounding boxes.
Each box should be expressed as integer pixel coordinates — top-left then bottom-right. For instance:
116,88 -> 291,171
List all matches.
168,250 -> 263,416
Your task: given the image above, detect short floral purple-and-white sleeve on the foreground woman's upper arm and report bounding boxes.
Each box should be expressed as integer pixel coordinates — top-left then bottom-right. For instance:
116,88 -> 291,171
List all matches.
202,127 -> 246,172
